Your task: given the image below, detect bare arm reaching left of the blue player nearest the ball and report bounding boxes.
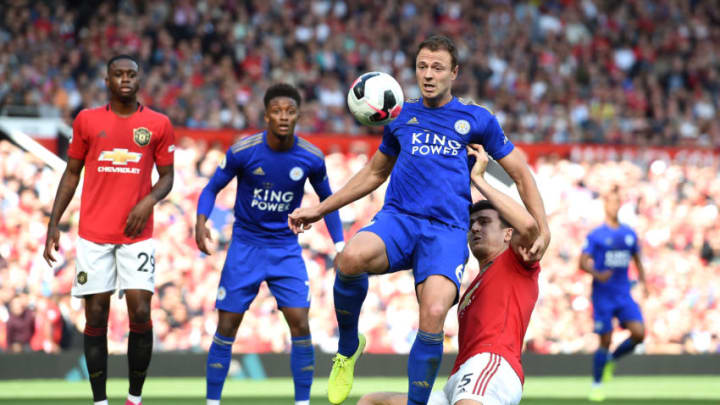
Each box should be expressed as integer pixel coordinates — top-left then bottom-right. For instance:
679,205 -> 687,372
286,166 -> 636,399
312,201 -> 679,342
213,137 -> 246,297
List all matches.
288,150 -> 397,233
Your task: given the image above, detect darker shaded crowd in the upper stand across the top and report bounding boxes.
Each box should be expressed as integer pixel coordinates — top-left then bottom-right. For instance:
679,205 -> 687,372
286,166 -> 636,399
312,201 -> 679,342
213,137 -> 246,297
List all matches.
0,0 -> 720,147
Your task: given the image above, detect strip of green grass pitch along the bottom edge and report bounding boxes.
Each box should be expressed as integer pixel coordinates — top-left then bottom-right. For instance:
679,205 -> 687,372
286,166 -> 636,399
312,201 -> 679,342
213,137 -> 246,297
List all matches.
0,376 -> 720,405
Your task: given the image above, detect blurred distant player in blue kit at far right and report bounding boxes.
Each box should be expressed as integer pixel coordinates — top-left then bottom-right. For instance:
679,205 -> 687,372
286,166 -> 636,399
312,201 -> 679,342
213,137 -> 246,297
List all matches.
580,188 -> 647,401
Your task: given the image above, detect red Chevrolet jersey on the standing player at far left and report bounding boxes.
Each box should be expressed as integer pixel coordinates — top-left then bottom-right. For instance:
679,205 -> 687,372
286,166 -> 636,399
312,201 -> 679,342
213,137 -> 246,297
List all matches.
68,105 -> 175,244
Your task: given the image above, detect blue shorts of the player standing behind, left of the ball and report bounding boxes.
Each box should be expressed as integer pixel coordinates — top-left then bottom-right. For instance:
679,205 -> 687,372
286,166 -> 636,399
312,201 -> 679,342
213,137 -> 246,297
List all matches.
215,238 -> 310,313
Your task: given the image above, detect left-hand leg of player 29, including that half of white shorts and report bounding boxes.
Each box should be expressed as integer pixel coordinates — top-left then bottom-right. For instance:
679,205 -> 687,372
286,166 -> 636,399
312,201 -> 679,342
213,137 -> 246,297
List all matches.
72,238 -> 117,405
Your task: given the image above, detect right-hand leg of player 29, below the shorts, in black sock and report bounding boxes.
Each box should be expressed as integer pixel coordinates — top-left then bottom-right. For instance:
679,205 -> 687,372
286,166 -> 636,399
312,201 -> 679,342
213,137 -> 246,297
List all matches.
125,289 -> 153,405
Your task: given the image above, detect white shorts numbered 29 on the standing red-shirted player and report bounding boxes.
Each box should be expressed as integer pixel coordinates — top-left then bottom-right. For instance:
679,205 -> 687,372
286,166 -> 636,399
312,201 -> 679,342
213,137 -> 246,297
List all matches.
72,238 -> 155,298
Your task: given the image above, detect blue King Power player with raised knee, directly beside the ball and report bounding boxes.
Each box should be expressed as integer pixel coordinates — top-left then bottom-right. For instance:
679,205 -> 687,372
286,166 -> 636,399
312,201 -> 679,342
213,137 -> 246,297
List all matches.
289,36 -> 550,405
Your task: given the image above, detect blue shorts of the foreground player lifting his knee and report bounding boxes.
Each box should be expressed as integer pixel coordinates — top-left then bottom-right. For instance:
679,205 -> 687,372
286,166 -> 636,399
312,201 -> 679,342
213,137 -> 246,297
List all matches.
360,211 -> 469,300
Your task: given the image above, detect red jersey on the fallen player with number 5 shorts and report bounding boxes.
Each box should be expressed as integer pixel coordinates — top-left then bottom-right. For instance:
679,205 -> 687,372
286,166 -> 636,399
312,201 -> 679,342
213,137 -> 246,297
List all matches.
451,248 -> 540,383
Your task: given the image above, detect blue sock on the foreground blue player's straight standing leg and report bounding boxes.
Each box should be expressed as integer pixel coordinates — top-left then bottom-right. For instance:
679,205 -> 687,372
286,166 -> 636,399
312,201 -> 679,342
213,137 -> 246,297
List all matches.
408,330 -> 444,405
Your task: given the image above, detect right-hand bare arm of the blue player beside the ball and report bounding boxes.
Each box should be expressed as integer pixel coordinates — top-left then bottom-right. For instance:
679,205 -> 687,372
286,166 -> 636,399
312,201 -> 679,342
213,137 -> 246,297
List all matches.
498,149 -> 550,261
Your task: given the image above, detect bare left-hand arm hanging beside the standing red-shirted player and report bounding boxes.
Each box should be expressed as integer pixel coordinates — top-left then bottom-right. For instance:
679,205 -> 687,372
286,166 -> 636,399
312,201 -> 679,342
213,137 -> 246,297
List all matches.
43,158 -> 85,267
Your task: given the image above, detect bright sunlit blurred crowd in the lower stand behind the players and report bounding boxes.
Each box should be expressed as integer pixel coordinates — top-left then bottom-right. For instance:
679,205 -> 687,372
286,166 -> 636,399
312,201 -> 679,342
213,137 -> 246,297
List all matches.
0,138 -> 720,353
